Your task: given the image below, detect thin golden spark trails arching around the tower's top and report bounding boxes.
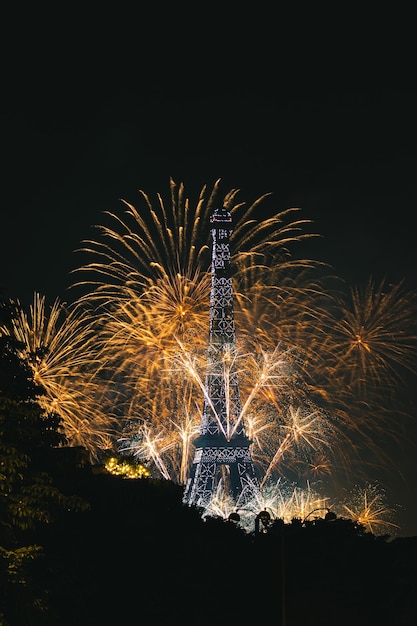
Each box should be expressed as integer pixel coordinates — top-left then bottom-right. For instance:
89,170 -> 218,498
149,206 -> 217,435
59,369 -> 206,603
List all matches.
73,180 -> 317,302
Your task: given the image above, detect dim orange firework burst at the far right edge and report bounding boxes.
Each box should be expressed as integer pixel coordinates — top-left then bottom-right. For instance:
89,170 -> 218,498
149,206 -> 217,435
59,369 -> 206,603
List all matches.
316,279 -> 417,395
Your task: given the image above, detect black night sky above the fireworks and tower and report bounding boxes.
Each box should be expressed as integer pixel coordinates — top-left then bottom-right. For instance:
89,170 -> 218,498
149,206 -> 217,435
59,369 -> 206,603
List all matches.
0,8 -> 417,535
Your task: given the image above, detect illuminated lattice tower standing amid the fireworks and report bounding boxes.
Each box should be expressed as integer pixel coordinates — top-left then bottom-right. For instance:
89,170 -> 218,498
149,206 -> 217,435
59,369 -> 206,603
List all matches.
183,208 -> 259,507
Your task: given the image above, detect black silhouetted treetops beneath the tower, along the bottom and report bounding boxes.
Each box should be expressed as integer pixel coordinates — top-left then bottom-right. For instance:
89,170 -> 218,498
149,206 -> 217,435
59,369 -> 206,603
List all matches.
35,454 -> 417,626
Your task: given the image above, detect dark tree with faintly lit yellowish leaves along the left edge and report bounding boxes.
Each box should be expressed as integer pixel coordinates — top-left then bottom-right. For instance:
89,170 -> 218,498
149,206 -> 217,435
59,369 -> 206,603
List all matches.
0,305 -> 87,626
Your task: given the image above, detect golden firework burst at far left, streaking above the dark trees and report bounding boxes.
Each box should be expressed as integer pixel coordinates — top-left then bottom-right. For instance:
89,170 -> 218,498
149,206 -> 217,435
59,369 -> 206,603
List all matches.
0,292 -> 115,459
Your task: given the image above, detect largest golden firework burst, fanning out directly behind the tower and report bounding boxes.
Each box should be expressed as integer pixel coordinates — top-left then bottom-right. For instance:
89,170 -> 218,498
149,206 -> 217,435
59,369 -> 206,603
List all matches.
70,181 -> 348,482
